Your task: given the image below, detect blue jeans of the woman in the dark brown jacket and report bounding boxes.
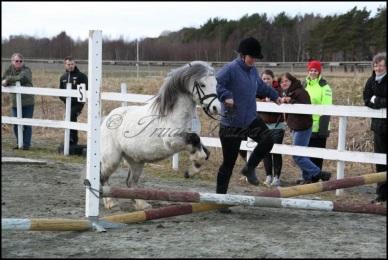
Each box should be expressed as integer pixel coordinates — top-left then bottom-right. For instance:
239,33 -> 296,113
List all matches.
292,127 -> 321,181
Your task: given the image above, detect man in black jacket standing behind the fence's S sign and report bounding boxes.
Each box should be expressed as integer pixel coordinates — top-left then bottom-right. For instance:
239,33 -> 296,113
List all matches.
59,56 -> 88,145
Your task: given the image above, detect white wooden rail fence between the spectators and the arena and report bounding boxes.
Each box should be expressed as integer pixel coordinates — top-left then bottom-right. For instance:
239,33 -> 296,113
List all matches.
2,84 -> 386,192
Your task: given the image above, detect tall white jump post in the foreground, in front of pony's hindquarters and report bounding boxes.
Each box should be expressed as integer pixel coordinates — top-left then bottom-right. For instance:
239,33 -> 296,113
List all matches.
85,30 -> 102,219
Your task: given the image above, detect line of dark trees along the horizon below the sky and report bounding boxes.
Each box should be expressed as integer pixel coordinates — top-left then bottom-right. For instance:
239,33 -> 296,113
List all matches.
1,7 -> 387,62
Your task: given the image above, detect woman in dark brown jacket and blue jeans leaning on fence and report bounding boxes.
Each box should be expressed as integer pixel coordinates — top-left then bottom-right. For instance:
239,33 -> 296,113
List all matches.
278,72 -> 331,184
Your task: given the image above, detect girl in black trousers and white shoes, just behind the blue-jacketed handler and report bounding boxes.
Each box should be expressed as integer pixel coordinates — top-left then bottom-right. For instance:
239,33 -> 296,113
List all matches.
258,70 -> 286,187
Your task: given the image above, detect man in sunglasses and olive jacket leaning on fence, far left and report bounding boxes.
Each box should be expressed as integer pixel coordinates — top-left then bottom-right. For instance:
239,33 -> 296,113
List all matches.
1,53 -> 35,150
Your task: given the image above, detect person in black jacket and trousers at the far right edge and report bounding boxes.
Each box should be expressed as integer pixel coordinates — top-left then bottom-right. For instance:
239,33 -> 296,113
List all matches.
363,52 -> 387,201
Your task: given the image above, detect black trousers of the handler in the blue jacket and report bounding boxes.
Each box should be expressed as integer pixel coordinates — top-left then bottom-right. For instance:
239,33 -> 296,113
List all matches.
216,117 -> 274,194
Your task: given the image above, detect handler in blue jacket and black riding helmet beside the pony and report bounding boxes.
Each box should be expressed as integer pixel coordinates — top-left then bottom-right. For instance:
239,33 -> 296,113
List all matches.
216,37 -> 281,201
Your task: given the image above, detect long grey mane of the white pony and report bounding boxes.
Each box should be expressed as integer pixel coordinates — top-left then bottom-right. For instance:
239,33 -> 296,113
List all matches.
152,61 -> 214,116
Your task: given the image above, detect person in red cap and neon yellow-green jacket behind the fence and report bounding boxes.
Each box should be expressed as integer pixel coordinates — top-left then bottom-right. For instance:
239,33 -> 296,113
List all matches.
304,60 -> 333,179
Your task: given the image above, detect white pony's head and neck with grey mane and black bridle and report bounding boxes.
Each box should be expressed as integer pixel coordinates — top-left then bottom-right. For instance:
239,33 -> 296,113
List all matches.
153,61 -> 221,115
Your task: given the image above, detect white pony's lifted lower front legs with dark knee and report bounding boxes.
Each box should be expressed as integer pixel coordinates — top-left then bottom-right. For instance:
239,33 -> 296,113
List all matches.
184,133 -> 210,178
